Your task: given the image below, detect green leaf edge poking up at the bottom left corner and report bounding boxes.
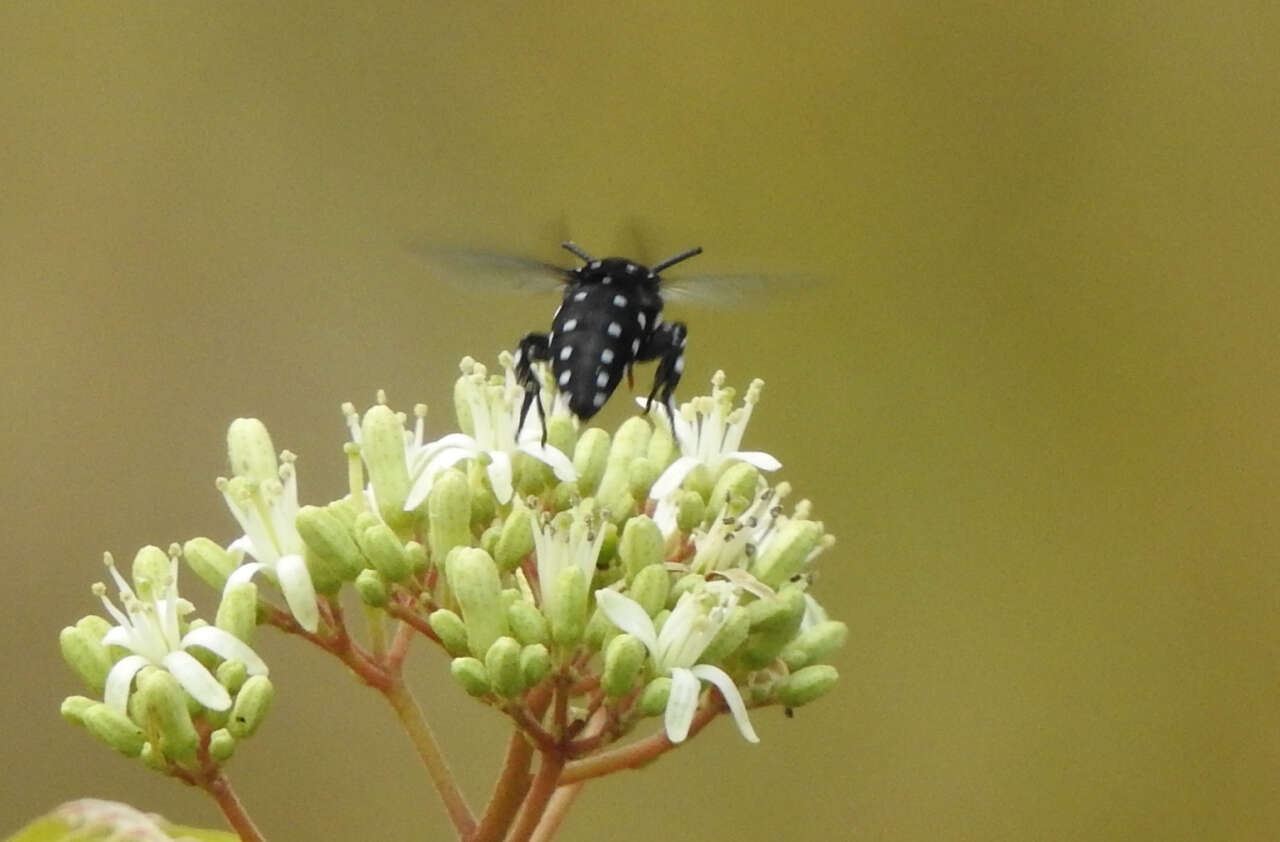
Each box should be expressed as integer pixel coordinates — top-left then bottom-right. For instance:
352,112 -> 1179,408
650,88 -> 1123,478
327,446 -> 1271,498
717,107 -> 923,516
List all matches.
4,798 -> 238,842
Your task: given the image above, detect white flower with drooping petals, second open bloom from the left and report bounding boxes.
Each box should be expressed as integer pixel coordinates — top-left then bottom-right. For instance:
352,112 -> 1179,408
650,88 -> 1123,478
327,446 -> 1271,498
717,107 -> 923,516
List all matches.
218,418 -> 320,632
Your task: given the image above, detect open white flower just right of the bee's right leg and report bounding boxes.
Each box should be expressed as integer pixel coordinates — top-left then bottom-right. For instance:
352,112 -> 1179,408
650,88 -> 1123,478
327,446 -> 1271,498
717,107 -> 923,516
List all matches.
637,371 -> 782,500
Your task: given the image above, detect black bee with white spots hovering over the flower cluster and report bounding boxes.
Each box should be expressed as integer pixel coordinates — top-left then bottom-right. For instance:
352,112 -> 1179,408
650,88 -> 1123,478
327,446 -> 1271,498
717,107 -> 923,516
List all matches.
515,242 -> 703,436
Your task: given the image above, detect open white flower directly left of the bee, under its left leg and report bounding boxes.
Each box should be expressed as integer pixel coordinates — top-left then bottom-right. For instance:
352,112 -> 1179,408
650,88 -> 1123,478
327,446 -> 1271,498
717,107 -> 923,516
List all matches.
404,353 -> 577,509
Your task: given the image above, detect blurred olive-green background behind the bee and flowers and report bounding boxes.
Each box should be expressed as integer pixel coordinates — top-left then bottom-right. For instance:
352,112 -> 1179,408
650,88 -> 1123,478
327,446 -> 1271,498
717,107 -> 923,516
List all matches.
0,1 -> 1280,842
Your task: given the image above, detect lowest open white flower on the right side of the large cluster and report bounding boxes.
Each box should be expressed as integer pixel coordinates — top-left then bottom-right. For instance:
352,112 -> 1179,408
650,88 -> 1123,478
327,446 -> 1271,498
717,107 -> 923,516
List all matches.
595,582 -> 760,742
